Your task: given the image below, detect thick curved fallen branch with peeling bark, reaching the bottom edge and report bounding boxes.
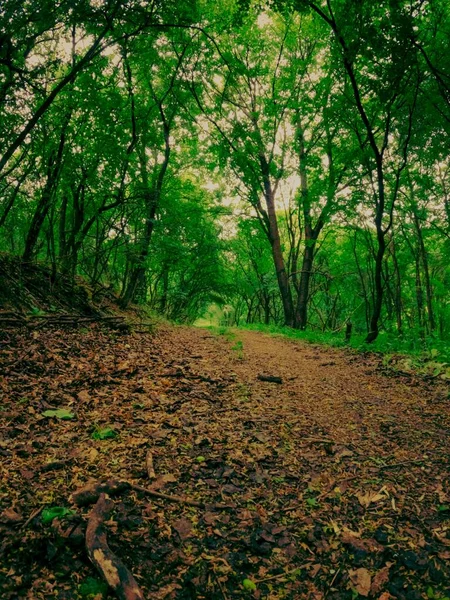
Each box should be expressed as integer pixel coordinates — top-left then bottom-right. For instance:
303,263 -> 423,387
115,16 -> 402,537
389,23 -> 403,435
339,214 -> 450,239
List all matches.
86,494 -> 145,600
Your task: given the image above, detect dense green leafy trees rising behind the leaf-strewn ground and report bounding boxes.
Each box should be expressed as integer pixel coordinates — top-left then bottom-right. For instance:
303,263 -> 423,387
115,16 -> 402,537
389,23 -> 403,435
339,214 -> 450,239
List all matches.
0,0 -> 450,342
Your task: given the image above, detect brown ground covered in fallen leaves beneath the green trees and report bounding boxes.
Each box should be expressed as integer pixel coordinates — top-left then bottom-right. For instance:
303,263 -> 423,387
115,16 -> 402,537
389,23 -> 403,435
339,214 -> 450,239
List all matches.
0,325 -> 450,600
